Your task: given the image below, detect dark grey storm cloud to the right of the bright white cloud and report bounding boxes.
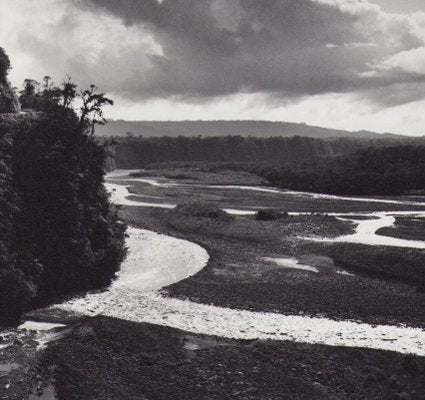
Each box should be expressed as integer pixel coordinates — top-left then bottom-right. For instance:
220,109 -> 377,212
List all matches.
73,0 -> 423,98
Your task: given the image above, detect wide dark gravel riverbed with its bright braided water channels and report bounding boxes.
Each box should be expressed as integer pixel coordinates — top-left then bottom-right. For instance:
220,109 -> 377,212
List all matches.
0,172 -> 425,399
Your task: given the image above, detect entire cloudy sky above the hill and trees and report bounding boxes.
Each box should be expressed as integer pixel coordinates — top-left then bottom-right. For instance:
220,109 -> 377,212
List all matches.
0,0 -> 425,136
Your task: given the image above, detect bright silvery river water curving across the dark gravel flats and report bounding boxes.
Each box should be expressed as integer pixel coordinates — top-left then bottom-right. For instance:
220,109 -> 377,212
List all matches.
39,170 -> 425,356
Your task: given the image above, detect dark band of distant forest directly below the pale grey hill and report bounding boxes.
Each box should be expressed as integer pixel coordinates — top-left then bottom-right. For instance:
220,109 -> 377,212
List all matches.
106,136 -> 408,169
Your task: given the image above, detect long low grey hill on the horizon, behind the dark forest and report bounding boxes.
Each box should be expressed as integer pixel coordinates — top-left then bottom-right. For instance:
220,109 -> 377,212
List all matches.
96,120 -> 405,139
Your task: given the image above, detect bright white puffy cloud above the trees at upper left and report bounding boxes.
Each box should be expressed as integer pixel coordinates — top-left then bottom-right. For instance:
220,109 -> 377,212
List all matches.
0,0 -> 161,94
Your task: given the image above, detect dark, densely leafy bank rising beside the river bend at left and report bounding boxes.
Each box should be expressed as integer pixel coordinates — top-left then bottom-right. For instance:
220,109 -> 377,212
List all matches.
0,60 -> 125,322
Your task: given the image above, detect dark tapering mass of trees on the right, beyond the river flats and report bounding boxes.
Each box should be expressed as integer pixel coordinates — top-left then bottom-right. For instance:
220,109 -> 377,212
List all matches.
255,145 -> 425,195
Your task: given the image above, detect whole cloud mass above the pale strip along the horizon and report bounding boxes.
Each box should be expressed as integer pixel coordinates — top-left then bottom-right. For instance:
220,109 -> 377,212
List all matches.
0,0 -> 425,105
